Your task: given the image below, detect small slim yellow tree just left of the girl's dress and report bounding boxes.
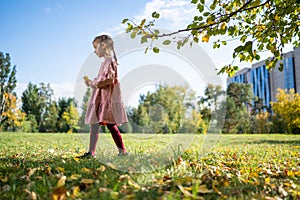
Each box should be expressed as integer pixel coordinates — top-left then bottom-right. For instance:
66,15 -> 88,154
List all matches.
62,101 -> 79,133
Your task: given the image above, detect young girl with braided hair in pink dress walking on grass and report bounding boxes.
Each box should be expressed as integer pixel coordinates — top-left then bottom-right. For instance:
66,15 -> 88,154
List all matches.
77,35 -> 128,158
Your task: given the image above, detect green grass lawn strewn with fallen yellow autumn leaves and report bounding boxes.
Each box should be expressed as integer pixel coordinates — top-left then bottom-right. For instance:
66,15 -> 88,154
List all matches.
0,133 -> 300,199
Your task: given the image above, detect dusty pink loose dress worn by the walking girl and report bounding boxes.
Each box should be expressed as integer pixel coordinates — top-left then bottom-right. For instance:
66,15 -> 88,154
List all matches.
85,57 -> 128,125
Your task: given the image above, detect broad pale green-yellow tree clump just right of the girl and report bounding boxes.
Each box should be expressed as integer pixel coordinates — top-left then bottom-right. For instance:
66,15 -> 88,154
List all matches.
130,85 -> 197,133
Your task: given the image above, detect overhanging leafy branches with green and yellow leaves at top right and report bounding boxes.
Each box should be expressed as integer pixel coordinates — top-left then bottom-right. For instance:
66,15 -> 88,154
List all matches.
123,0 -> 300,75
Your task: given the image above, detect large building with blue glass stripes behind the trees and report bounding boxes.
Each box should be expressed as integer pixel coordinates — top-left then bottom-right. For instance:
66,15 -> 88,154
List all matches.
227,47 -> 300,107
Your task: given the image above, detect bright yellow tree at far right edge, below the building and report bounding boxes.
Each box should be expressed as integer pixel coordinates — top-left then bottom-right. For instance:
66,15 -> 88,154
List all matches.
271,88 -> 300,133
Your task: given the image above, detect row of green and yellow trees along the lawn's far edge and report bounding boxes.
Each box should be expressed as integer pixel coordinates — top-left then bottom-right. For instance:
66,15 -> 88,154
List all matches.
0,52 -> 300,134
